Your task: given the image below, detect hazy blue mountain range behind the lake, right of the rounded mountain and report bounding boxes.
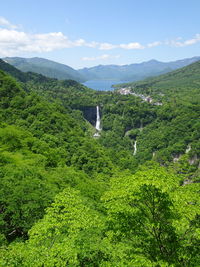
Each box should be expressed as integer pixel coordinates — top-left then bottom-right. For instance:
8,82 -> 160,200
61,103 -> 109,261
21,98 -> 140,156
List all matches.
78,57 -> 200,81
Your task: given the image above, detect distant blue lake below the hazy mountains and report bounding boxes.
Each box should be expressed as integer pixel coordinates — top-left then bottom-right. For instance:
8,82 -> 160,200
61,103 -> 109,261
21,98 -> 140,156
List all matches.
83,80 -> 128,91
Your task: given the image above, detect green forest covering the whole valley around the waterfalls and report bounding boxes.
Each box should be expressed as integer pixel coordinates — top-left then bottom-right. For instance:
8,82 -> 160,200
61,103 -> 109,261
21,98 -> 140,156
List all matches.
0,60 -> 200,267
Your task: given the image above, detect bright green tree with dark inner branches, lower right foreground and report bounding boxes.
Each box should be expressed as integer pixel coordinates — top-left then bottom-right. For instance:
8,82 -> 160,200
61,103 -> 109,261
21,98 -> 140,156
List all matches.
103,163 -> 200,266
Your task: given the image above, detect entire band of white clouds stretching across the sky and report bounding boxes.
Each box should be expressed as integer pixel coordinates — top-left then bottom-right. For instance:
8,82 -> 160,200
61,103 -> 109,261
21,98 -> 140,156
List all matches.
0,17 -> 200,57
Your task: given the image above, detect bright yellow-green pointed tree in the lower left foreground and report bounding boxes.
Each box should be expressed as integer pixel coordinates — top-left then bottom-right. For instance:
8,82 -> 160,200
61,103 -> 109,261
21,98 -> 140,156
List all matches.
2,188 -> 104,267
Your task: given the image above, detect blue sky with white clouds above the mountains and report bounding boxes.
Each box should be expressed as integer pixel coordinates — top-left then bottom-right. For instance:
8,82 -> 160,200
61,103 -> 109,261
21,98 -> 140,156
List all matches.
0,0 -> 200,69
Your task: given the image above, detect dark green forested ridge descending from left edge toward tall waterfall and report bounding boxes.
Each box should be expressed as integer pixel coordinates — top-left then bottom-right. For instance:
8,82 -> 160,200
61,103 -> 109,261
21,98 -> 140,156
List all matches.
0,59 -> 92,114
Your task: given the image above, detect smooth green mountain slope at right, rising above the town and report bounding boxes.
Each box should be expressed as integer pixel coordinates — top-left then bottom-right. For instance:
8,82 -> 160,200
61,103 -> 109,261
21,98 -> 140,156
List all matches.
116,61 -> 200,101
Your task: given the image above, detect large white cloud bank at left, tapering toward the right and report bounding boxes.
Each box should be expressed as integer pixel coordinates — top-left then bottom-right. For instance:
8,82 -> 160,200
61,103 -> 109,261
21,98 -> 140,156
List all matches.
0,25 -> 144,56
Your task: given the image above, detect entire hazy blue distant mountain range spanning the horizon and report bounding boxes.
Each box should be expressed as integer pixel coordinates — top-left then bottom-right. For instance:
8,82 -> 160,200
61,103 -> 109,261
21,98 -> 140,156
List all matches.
3,57 -> 200,82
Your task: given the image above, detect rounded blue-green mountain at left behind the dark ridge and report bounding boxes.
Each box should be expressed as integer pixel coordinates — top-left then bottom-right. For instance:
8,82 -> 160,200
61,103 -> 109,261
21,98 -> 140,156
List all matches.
3,57 -> 85,82
